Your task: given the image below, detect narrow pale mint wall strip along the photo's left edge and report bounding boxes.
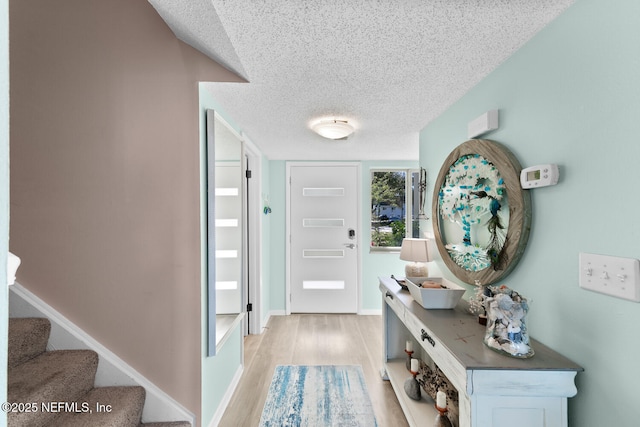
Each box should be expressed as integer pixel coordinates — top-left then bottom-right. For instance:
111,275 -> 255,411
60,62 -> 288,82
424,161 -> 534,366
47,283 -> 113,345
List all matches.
0,0 -> 9,418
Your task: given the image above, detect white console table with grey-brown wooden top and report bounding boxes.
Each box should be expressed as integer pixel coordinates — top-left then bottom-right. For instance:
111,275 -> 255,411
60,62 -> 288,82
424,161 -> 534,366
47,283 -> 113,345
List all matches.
380,277 -> 582,427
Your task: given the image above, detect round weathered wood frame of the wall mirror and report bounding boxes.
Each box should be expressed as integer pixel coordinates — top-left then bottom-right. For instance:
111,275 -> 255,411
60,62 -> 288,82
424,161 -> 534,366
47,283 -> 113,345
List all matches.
432,139 -> 531,285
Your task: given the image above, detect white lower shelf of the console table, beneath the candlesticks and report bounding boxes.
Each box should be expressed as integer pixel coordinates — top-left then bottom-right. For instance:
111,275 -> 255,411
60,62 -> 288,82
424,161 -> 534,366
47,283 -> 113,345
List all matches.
385,359 -> 438,427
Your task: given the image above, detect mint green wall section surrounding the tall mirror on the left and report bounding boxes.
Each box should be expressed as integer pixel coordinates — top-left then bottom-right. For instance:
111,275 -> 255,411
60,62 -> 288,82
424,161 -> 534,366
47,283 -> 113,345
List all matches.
198,84 -> 242,426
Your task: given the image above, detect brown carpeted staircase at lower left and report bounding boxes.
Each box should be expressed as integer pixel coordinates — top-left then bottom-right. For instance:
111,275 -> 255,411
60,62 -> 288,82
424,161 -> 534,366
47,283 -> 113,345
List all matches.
7,318 -> 191,427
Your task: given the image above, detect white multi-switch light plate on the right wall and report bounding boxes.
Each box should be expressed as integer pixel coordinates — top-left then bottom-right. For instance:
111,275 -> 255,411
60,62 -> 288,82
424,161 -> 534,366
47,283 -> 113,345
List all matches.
579,253 -> 640,302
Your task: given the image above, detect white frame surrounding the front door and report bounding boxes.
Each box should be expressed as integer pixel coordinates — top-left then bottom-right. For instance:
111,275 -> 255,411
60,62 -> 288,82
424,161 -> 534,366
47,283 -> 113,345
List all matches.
284,162 -> 363,315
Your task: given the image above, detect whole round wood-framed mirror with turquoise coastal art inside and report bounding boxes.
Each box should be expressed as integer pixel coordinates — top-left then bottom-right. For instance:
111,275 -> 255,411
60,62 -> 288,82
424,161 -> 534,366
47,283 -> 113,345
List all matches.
432,139 -> 531,285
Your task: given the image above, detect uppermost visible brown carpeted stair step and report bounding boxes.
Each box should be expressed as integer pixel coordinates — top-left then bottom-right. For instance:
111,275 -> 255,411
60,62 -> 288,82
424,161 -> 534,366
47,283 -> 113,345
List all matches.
7,317 -> 51,368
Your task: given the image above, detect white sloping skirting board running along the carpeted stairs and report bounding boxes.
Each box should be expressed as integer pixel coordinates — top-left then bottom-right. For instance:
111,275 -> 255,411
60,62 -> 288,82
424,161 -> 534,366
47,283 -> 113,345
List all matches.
9,283 -> 196,426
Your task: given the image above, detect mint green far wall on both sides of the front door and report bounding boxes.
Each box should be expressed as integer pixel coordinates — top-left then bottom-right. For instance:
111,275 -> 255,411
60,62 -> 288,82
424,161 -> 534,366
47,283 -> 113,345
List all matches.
269,160 -> 418,313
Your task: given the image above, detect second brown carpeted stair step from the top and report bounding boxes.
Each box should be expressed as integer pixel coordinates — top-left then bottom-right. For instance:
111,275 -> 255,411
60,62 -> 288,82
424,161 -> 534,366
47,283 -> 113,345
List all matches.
7,350 -> 98,427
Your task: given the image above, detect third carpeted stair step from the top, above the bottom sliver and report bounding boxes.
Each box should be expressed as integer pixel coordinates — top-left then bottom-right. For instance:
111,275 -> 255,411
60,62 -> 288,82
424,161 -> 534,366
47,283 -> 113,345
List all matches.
49,386 -> 145,427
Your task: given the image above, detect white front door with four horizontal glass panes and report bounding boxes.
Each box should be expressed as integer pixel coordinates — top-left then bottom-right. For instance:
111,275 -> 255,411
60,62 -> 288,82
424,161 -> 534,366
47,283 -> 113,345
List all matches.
287,163 -> 360,313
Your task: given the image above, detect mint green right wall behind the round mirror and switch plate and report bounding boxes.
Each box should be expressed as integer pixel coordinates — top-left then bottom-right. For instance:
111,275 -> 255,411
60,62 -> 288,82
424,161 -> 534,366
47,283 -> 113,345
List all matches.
420,0 -> 640,427
